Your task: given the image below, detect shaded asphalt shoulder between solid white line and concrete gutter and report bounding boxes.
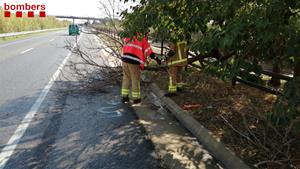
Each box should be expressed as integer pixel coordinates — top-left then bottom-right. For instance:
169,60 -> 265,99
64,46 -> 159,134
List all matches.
1,81 -> 160,169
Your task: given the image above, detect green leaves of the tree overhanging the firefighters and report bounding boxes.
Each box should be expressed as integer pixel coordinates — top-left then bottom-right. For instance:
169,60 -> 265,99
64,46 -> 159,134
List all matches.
121,0 -> 300,131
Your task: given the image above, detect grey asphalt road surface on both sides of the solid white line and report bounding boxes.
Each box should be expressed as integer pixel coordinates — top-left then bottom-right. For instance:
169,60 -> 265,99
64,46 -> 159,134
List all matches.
0,31 -> 160,169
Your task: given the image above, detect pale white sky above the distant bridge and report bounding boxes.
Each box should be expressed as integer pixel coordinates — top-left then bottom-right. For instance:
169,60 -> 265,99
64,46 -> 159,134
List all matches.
0,0 -> 137,18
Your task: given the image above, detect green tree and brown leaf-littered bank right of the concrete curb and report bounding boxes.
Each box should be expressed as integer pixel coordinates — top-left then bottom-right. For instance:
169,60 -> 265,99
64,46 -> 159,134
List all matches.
120,0 -> 300,169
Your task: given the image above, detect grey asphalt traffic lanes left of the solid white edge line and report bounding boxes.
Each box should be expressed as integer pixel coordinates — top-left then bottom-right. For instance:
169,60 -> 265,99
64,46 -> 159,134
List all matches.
0,31 -> 70,148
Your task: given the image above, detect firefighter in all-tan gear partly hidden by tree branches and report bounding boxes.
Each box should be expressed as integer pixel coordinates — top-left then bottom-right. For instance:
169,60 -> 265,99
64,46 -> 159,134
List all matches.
166,41 -> 188,96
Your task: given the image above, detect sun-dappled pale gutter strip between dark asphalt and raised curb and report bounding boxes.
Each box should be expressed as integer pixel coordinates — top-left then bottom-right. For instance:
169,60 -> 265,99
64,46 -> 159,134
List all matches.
133,85 -> 221,169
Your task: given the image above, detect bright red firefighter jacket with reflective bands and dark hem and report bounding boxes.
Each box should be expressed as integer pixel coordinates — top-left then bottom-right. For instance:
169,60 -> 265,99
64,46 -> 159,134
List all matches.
122,36 -> 153,70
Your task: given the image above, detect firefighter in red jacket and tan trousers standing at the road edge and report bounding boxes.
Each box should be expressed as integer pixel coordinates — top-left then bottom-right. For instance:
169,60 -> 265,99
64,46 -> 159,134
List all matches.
121,32 -> 158,104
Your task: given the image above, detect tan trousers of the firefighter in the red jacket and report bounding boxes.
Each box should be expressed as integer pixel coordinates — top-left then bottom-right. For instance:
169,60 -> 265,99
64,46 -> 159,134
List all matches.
121,62 -> 141,100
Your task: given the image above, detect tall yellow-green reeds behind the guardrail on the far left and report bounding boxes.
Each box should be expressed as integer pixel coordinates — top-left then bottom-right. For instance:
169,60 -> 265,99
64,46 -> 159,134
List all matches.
0,8 -> 69,33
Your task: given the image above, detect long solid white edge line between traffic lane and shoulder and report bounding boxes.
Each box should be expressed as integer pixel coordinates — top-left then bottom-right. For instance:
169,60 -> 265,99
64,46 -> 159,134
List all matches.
0,36 -> 81,169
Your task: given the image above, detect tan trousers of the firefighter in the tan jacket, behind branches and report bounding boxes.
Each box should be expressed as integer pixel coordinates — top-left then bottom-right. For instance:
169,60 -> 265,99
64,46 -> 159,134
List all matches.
168,66 -> 184,93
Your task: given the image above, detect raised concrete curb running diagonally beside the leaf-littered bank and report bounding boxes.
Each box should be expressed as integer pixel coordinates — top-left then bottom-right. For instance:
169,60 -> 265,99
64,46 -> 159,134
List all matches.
137,83 -> 250,169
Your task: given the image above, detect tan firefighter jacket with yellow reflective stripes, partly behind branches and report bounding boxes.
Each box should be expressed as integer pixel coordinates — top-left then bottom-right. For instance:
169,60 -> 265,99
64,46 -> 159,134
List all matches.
167,41 -> 188,66
